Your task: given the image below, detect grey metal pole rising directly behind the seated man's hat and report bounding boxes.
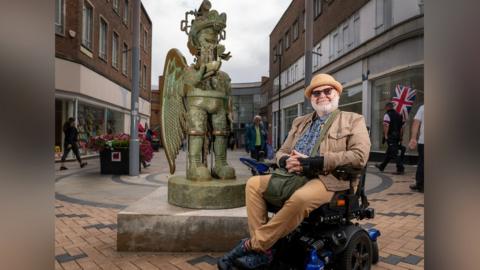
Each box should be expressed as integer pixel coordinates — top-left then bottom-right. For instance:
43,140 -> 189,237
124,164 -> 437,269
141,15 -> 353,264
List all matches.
303,0 -> 313,114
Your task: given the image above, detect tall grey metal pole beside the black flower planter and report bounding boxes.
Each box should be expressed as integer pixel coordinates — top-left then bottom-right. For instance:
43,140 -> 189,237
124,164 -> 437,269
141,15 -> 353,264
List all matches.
129,0 -> 140,176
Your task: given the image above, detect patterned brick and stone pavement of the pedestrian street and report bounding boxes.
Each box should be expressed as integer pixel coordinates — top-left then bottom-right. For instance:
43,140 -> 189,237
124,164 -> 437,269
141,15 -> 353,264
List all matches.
55,151 -> 424,270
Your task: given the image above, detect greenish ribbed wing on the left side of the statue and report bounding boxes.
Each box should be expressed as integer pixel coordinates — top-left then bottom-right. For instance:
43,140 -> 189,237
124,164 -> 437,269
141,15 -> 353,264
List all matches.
159,49 -> 187,174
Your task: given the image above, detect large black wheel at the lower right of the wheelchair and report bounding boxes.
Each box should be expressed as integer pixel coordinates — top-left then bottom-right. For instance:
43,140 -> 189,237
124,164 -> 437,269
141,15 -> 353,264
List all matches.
339,231 -> 372,270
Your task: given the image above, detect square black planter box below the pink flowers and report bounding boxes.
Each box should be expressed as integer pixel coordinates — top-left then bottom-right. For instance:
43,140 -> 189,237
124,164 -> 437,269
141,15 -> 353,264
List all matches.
100,148 -> 141,174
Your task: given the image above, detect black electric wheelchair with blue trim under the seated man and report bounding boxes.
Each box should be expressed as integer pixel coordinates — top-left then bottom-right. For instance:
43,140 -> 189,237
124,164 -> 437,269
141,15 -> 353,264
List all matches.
235,160 -> 380,270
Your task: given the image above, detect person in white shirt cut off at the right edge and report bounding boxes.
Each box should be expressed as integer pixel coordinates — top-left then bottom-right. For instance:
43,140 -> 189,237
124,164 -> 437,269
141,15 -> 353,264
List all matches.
408,105 -> 425,192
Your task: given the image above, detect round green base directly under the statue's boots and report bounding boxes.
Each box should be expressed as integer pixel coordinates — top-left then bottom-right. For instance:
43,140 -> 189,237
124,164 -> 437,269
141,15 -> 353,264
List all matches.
168,176 -> 247,209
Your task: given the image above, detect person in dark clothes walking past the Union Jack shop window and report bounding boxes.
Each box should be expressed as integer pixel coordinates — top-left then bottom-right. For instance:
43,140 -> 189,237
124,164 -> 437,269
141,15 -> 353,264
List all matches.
375,102 -> 405,174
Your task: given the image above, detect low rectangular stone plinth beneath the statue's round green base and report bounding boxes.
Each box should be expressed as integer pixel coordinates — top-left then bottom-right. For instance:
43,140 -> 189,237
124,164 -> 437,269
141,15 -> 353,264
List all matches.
117,186 -> 248,252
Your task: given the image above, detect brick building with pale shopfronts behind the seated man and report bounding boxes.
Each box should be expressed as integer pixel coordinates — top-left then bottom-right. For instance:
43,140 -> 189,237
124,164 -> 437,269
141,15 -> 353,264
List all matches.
266,0 -> 424,156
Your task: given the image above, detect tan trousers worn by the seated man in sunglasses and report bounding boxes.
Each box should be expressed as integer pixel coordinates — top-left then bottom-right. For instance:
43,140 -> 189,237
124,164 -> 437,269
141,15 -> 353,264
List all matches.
245,175 -> 334,251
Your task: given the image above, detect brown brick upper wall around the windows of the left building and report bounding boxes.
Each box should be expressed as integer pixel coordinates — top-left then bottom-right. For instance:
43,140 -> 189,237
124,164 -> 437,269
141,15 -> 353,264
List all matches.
55,0 -> 152,100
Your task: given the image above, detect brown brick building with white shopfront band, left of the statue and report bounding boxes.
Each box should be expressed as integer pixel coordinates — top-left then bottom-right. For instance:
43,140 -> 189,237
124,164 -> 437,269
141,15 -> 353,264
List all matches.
55,0 -> 152,155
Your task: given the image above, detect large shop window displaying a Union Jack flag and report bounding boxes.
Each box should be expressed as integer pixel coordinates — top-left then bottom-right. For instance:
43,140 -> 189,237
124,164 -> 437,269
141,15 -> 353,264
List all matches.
371,68 -> 424,151
